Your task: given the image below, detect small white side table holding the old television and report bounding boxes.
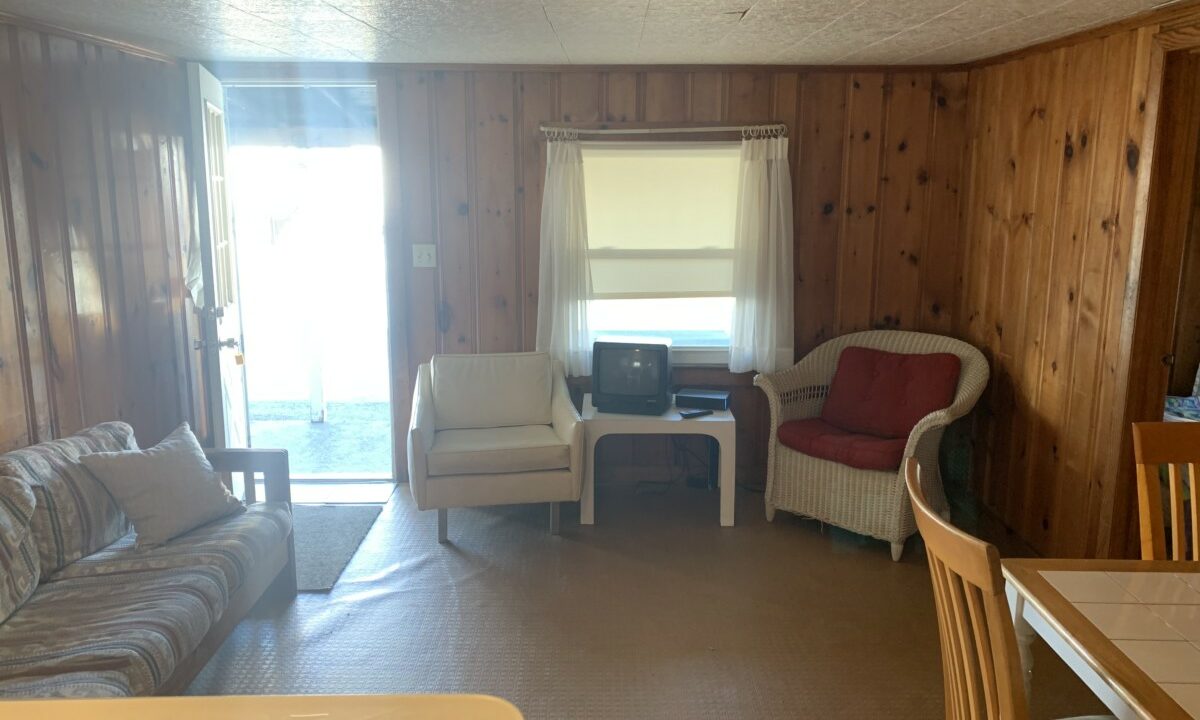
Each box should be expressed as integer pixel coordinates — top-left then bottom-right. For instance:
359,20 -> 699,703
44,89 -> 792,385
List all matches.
580,392 -> 738,527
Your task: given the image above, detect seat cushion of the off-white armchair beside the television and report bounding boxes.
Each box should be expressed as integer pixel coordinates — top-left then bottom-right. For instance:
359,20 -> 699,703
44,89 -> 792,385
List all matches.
426,425 -> 571,476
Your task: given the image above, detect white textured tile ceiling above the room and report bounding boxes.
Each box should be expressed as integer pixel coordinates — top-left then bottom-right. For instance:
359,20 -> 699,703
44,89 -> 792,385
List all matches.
0,0 -> 1169,65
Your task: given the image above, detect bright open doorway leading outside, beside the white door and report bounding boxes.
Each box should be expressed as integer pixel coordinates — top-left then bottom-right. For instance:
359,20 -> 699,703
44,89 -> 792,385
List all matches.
224,84 -> 394,489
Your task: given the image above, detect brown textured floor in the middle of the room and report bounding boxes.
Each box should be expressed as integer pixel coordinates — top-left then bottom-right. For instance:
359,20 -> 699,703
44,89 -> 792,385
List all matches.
190,486 -> 1102,720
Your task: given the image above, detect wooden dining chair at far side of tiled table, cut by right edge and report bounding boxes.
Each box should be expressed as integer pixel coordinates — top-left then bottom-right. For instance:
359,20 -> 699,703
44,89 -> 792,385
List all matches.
1133,422 -> 1200,560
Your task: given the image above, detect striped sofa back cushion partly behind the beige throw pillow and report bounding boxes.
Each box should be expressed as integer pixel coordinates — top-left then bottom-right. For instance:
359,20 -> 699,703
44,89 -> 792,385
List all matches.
0,422 -> 138,575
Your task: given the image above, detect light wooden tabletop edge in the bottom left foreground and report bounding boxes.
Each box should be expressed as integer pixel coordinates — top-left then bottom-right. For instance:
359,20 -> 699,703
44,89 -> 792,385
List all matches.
0,695 -> 523,720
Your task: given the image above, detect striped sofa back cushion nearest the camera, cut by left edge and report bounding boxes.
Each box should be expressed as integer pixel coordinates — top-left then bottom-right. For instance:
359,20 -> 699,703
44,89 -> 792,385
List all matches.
0,476 -> 41,623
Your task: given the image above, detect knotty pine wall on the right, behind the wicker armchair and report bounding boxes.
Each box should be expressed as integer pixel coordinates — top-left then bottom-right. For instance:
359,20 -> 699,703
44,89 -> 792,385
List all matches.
955,29 -> 1154,557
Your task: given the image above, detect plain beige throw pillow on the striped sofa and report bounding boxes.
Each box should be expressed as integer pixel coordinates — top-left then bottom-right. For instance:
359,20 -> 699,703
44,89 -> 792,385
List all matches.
79,422 -> 245,547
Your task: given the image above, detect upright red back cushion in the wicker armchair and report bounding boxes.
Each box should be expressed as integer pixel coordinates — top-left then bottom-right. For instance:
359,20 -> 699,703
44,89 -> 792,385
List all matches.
821,347 -> 962,438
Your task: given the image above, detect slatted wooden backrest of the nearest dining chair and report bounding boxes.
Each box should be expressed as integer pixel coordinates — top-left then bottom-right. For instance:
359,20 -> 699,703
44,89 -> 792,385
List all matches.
905,458 -> 1028,720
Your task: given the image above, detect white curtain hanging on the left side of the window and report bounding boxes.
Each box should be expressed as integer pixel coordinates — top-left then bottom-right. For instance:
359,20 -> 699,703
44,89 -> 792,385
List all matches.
536,137 -> 592,376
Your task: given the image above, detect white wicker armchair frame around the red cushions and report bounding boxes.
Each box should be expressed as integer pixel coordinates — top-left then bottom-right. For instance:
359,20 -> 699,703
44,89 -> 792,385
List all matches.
754,330 -> 989,560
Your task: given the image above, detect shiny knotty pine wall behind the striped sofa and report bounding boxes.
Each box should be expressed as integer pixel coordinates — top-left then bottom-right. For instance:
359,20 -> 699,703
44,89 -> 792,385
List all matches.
0,24 -> 203,451
